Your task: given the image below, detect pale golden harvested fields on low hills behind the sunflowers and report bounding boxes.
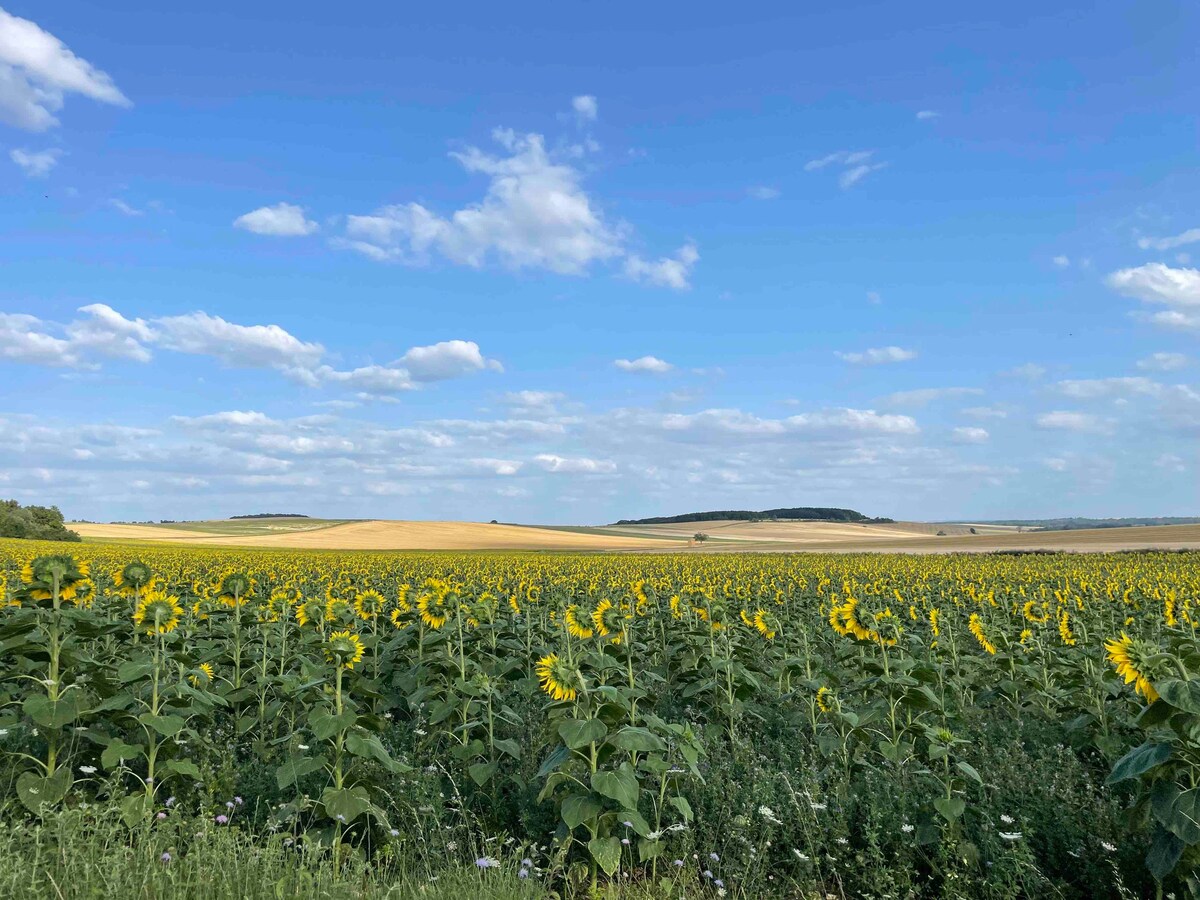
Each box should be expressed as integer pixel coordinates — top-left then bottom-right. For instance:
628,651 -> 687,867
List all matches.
71,520 -> 1200,553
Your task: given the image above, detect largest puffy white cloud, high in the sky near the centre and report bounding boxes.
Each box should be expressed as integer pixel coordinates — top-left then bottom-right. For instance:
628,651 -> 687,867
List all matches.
337,130 -> 623,275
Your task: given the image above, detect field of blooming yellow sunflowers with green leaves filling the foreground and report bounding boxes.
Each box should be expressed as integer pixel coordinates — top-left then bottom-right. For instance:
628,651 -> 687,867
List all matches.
0,541 -> 1200,898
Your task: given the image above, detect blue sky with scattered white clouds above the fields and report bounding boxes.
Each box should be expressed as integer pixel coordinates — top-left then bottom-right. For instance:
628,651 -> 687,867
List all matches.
0,0 -> 1200,523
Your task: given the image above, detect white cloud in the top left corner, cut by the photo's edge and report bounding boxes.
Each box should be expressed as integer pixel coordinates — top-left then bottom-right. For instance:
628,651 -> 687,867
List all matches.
0,8 -> 131,131
